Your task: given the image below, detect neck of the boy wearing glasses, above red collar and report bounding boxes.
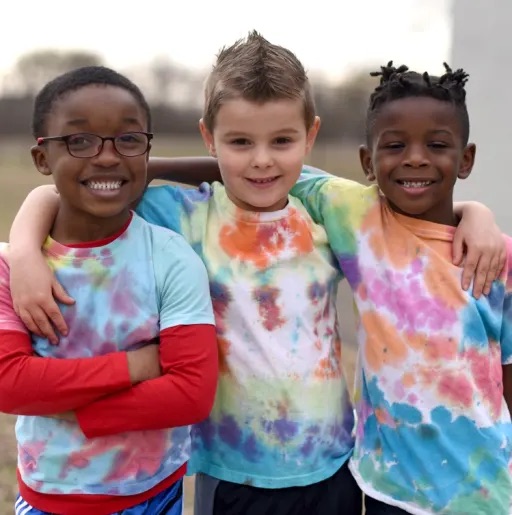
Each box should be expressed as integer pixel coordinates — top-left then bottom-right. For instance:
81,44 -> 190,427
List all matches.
50,205 -> 130,245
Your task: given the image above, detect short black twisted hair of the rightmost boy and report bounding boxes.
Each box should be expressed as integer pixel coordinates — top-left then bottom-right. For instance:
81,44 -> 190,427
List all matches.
366,61 -> 469,145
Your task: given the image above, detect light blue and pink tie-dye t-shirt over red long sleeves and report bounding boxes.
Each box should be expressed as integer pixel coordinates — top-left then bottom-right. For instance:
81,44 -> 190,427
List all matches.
0,215 -> 213,495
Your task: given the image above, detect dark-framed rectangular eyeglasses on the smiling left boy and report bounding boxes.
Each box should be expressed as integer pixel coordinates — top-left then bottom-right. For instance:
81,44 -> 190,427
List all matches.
37,132 -> 153,158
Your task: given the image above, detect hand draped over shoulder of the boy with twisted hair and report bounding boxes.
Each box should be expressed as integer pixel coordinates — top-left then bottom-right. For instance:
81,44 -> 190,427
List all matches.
453,202 -> 507,299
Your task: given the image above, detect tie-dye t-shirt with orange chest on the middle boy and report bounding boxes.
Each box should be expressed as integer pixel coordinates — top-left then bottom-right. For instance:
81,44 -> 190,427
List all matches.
138,183 -> 353,488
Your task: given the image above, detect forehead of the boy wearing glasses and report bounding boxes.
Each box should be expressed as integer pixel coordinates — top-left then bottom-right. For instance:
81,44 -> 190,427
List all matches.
47,84 -> 147,128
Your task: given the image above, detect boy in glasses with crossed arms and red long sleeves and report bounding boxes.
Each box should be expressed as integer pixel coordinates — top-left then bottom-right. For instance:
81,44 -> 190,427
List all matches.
0,67 -> 218,515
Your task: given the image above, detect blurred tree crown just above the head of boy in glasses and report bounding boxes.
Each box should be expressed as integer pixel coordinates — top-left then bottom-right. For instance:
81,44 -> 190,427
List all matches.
14,49 -> 103,96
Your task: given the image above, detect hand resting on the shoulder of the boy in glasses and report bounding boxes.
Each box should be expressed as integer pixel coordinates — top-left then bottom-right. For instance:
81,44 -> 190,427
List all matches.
8,252 -> 75,345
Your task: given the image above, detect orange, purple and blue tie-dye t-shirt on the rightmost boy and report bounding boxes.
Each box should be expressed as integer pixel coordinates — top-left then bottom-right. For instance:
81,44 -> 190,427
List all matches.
292,172 -> 512,515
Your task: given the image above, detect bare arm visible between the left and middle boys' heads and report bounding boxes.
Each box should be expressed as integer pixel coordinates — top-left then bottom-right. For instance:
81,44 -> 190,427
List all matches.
148,157 -> 221,186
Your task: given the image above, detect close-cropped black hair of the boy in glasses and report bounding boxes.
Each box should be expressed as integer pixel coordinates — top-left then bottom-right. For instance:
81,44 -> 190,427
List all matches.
32,66 -> 151,138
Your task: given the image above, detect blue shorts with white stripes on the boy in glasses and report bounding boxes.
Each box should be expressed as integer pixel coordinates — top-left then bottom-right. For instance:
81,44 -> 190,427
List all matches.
14,479 -> 183,515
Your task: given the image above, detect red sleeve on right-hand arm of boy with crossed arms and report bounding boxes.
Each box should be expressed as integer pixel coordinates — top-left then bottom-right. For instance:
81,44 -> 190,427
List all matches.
76,324 -> 219,438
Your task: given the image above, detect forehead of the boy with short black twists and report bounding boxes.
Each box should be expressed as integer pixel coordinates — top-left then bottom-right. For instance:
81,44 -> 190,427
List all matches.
373,97 -> 461,135
